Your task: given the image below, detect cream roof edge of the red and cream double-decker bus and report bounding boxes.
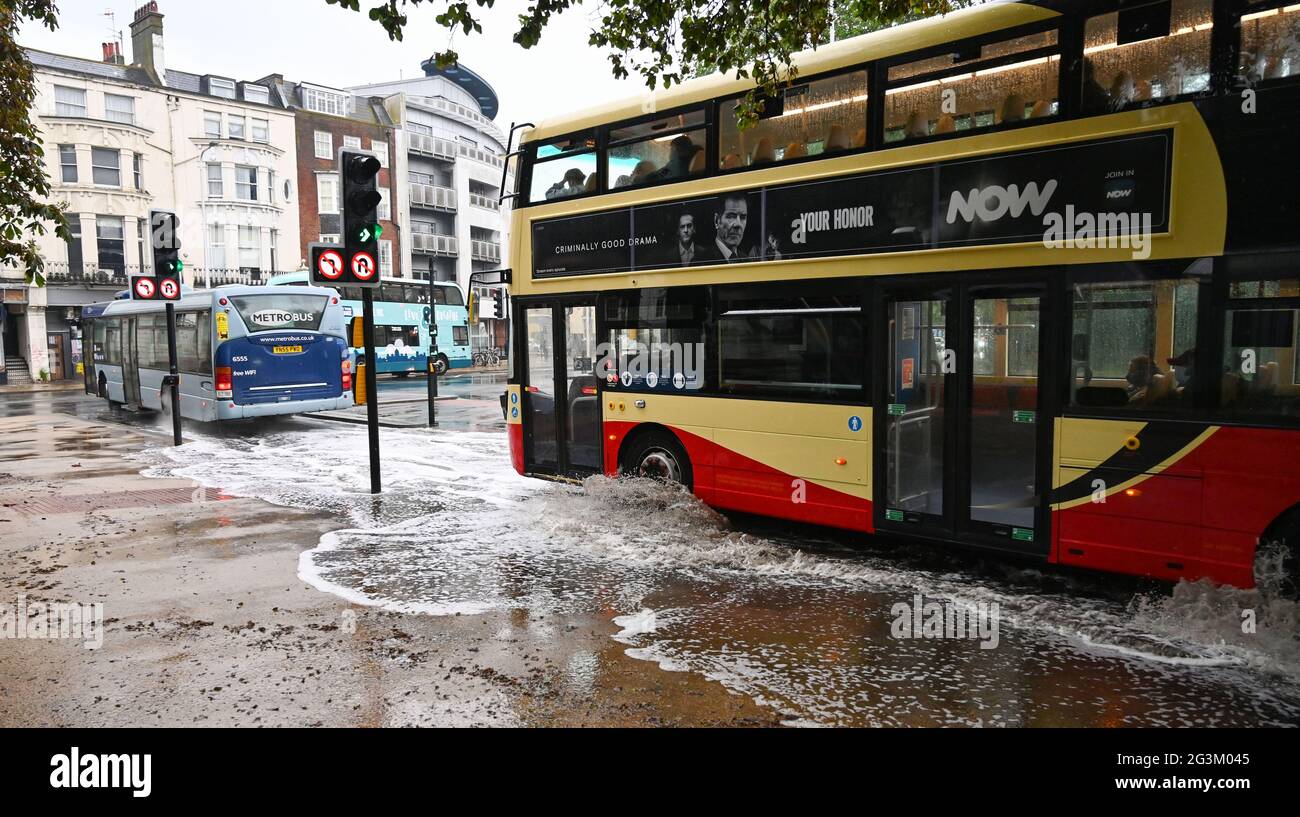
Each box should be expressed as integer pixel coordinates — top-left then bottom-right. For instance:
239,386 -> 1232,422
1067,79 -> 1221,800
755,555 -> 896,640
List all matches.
523,0 -> 1060,142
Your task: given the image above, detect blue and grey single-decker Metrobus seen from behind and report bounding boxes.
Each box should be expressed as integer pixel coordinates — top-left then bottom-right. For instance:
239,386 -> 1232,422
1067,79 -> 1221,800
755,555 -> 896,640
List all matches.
82,285 -> 354,422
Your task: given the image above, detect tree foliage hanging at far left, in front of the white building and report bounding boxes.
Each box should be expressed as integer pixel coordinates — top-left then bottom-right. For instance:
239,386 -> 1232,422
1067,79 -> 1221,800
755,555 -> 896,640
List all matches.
0,0 -> 72,286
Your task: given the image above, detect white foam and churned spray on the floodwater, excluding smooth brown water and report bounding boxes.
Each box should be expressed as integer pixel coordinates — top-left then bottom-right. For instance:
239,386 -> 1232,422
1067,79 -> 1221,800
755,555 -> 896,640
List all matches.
142,425 -> 1300,725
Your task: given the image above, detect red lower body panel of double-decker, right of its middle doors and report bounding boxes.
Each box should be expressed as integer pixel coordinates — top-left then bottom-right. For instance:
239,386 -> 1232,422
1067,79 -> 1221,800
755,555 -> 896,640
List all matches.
1053,428 -> 1300,587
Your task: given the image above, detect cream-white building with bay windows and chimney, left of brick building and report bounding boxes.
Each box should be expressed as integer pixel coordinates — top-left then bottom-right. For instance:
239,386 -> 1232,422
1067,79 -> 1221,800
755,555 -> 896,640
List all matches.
0,3 -> 302,382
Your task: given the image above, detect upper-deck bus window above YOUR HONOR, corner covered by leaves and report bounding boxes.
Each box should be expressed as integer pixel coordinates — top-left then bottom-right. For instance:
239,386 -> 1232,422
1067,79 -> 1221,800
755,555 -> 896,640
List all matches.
718,72 -> 867,170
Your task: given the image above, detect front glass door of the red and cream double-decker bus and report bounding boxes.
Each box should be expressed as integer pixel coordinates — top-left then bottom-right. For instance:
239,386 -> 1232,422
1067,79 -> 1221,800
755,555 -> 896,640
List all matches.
520,298 -> 601,476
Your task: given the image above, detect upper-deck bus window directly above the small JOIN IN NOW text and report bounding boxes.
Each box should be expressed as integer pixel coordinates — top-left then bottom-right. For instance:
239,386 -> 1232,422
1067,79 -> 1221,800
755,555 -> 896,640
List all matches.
1080,0 -> 1214,113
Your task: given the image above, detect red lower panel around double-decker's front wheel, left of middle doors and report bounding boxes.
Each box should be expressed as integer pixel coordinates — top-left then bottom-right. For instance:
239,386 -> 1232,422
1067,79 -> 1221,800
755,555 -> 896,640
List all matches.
605,422 -> 874,532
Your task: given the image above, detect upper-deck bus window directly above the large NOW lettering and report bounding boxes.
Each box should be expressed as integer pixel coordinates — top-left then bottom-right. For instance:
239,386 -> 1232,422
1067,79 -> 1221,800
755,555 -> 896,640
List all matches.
883,30 -> 1061,143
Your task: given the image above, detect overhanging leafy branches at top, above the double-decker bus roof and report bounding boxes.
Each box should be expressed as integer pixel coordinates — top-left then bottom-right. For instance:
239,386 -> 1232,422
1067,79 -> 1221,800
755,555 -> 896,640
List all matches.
325,0 -> 956,127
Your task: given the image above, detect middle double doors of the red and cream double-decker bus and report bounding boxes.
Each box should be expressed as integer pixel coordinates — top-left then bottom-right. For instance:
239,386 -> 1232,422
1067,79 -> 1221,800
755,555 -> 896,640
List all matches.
875,285 -> 1050,556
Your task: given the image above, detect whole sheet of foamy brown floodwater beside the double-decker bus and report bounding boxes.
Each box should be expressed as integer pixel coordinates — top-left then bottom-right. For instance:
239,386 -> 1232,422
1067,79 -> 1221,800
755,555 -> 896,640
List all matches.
134,415 -> 1300,726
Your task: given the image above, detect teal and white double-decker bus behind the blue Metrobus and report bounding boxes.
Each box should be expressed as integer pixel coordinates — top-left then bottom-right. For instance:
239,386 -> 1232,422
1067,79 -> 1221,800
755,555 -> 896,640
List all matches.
267,272 -> 473,377
